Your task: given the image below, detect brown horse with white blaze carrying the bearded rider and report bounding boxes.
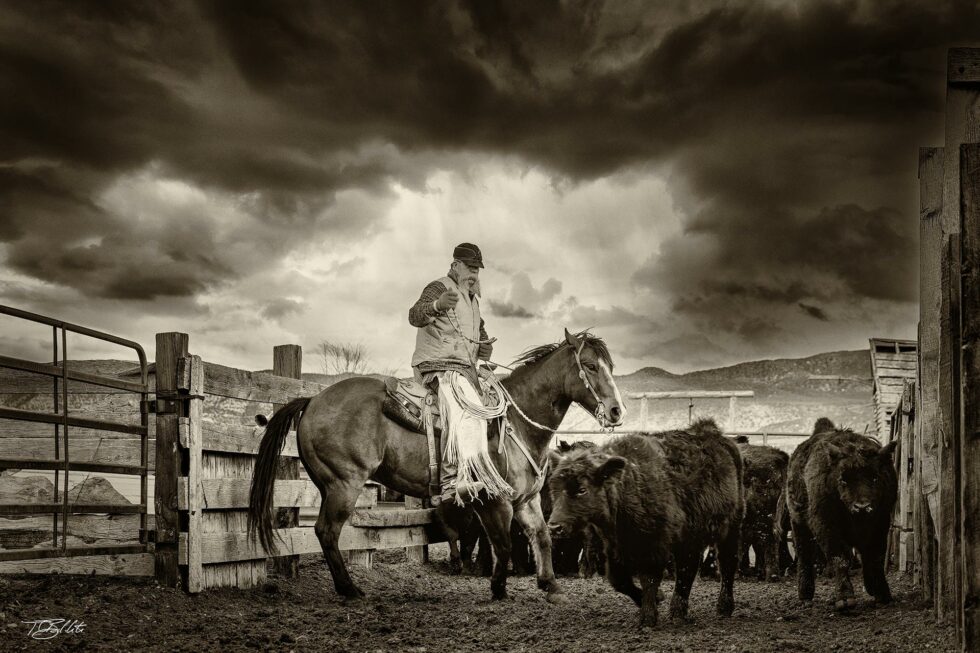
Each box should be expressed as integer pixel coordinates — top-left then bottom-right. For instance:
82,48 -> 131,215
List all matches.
248,330 -> 625,599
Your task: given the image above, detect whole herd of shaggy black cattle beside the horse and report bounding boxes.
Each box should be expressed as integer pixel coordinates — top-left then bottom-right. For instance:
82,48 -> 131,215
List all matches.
436,418 -> 897,625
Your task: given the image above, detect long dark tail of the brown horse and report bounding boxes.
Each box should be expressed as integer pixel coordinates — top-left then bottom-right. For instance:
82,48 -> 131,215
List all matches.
248,397 -> 311,554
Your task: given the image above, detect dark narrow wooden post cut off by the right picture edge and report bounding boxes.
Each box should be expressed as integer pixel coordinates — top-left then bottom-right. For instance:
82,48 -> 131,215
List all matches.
959,139 -> 980,651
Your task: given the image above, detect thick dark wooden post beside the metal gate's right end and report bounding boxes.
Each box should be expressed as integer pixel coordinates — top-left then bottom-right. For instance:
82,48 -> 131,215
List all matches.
154,333 -> 188,587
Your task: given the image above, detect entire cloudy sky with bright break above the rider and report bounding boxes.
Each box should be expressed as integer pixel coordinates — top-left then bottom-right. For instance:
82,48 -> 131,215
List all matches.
0,0 -> 980,373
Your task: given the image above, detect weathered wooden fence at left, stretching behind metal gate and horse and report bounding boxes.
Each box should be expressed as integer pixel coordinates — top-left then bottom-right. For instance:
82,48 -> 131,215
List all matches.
0,326 -> 445,592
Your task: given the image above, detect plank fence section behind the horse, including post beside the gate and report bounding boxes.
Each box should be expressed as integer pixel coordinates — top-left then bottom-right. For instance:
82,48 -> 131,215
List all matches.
156,333 -> 445,592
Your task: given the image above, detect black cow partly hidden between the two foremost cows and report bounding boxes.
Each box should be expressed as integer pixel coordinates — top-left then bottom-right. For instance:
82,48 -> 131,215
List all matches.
738,443 -> 789,581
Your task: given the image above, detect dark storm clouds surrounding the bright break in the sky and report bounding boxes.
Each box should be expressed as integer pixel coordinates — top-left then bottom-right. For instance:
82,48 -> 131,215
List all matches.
0,0 -> 980,314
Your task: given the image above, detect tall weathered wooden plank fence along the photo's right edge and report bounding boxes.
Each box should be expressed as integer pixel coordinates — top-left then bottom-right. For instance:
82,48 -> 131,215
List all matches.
893,48 -> 980,651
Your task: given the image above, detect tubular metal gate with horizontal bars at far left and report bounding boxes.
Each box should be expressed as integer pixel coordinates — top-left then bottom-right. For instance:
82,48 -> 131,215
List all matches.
0,305 -> 152,575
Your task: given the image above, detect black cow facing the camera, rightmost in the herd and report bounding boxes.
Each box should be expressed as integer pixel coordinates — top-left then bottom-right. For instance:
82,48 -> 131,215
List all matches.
786,418 -> 898,610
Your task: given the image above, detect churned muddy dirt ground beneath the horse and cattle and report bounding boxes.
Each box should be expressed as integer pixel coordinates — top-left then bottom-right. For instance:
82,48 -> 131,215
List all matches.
0,545 -> 955,653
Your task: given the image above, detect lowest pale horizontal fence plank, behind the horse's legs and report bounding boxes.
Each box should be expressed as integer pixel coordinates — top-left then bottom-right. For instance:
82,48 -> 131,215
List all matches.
178,524 -> 445,565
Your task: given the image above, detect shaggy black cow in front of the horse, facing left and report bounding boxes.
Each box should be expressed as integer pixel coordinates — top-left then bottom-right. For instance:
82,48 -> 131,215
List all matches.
548,420 -> 744,626
